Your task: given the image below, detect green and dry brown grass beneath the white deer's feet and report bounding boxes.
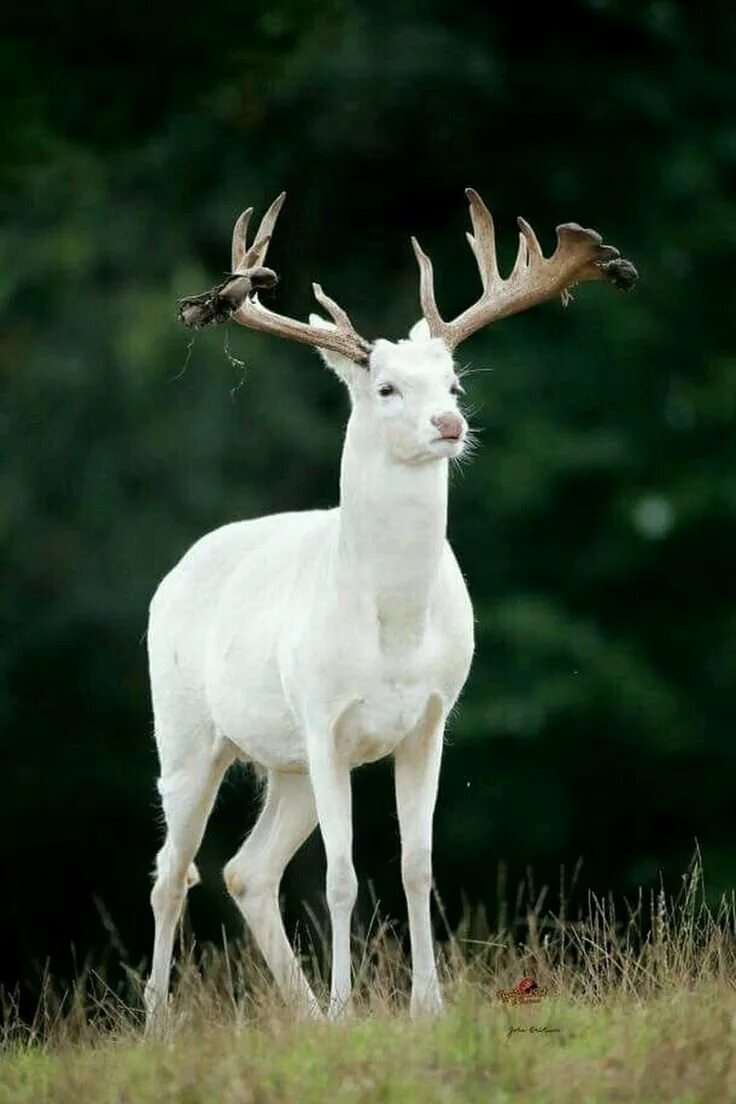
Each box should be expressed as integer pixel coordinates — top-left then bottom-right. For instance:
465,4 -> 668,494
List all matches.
0,864 -> 736,1104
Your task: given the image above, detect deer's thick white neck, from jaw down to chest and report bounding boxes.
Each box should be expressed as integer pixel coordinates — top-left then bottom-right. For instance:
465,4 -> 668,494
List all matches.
338,416 -> 448,649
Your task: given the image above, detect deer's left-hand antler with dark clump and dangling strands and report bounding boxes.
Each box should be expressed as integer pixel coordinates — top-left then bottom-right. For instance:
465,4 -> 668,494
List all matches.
179,192 -> 371,367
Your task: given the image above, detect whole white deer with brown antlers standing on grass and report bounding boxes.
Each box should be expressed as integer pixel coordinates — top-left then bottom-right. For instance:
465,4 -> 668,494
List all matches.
146,190 -> 637,1027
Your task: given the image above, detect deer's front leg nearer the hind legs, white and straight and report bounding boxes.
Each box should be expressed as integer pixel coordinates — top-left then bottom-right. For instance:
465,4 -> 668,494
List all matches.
308,731 -> 358,1018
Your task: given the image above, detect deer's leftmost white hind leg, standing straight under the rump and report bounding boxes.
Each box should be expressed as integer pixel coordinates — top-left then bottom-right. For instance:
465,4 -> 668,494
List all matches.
145,739 -> 234,1033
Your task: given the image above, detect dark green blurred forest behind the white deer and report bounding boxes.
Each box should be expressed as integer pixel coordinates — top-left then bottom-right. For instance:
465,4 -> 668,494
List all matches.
0,0 -> 736,998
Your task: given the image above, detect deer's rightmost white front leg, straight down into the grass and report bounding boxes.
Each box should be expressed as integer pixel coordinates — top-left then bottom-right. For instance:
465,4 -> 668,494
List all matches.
395,698 -> 445,1016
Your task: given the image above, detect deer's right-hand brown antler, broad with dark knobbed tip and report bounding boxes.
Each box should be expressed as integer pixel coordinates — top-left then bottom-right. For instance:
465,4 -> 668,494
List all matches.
412,188 -> 639,349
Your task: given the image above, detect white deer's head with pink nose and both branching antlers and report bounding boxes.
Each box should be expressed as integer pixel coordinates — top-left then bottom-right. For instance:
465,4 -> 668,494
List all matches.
180,189 -> 637,463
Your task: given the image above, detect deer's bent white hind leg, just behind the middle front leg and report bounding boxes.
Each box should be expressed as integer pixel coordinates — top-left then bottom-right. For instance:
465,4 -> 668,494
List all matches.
224,771 -> 321,1017
